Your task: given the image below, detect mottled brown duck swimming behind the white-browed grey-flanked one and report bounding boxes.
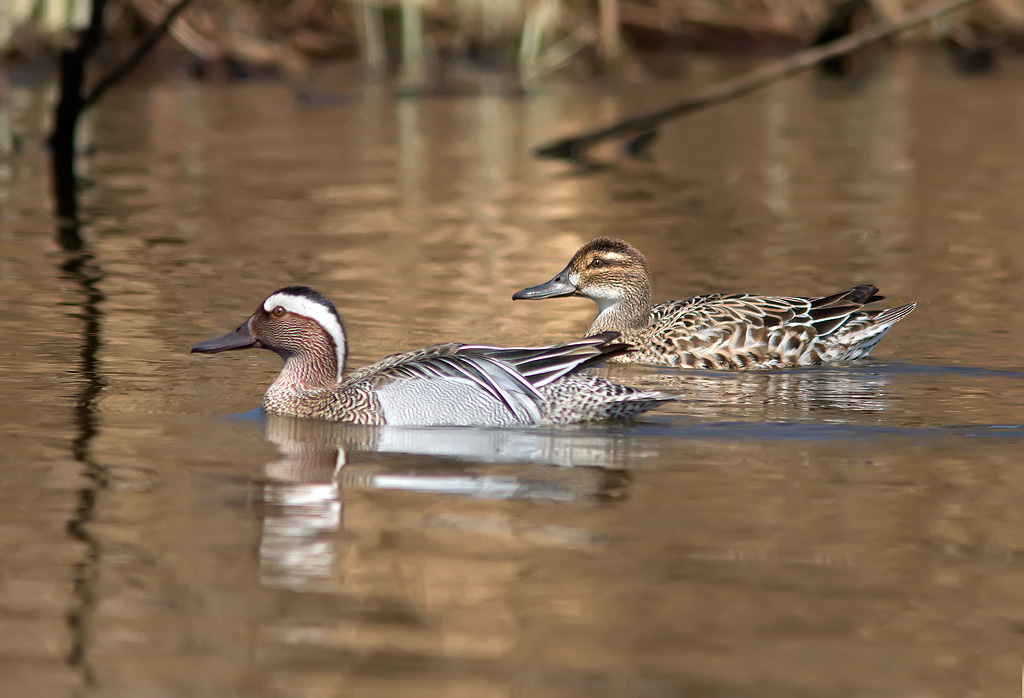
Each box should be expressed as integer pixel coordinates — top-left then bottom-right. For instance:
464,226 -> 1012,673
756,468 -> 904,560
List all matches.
512,237 -> 916,369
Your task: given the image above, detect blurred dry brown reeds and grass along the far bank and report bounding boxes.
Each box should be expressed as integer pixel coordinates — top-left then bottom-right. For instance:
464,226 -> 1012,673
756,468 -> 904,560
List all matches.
6,0 -> 1024,88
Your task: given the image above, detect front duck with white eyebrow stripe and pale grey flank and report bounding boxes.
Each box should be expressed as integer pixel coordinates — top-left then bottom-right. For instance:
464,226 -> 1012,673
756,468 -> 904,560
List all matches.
193,286 -> 675,426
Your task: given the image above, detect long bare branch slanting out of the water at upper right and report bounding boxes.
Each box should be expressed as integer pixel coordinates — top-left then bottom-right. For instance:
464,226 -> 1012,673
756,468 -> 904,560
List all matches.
534,0 -> 977,164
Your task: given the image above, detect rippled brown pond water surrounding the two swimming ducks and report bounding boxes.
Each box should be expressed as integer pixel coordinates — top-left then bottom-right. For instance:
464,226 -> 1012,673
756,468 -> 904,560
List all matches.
0,55 -> 1024,698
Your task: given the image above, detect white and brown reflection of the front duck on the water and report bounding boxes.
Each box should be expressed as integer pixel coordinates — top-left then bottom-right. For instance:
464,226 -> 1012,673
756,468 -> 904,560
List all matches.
253,415 -> 652,590
